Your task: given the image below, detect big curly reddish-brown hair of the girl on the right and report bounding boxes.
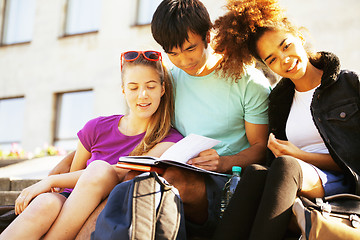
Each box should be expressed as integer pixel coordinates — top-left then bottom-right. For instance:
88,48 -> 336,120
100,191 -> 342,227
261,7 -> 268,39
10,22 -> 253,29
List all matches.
214,0 -> 288,79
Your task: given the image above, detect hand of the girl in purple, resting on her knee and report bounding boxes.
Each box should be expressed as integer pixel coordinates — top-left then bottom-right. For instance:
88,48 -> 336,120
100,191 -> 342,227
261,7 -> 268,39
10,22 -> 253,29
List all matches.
15,178 -> 51,215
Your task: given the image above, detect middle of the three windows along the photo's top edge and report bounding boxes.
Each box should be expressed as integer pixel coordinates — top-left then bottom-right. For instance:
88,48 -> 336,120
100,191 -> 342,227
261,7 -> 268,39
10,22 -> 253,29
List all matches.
65,0 -> 101,35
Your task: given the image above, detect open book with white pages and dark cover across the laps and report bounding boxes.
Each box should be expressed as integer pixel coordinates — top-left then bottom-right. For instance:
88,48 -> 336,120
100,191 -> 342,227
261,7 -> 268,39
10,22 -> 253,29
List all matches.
118,134 -> 227,176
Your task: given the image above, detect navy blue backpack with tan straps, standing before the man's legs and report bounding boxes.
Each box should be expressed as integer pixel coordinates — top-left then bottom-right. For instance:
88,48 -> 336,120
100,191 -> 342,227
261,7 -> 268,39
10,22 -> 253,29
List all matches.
91,172 -> 186,240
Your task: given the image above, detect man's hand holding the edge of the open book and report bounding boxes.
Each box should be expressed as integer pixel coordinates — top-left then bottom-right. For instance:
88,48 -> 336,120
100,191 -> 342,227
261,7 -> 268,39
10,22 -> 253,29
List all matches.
187,149 -> 220,172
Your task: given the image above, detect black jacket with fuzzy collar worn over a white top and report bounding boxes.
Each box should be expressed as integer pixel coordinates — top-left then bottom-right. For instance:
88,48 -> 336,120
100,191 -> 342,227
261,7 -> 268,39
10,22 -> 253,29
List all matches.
268,52 -> 360,195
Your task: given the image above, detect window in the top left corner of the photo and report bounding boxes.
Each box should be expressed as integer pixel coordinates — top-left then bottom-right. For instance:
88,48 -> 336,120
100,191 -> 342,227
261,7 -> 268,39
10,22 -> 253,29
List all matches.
2,0 -> 35,45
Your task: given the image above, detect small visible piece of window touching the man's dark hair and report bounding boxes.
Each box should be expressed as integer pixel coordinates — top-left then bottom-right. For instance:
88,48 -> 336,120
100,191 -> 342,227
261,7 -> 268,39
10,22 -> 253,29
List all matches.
136,0 -> 162,25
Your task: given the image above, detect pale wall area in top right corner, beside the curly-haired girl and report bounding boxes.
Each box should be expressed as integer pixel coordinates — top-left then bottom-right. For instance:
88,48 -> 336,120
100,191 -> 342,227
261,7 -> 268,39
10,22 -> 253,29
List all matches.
280,0 -> 360,73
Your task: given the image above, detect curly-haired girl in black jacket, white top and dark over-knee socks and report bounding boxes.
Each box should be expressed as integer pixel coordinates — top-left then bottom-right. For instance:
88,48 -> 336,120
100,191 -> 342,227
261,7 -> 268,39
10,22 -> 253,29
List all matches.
214,0 -> 360,240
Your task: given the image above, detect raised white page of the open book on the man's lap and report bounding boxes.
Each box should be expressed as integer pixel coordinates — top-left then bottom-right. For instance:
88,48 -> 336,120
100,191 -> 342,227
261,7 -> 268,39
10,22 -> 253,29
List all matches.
160,134 -> 220,163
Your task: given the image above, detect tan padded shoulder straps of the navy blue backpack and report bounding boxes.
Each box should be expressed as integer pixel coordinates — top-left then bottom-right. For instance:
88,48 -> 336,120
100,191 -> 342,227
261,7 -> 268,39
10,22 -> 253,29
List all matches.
131,172 -> 182,240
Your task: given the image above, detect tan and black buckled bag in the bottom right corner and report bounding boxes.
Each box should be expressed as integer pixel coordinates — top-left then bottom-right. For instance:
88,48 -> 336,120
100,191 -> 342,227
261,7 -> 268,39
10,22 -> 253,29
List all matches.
293,194 -> 360,240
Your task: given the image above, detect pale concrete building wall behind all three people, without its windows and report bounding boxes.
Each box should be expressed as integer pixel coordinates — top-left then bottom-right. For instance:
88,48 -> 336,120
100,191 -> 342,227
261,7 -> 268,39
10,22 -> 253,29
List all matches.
0,0 -> 360,151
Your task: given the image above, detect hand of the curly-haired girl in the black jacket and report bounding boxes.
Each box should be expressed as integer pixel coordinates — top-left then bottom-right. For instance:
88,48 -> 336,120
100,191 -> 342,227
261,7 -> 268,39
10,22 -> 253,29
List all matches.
268,133 -> 303,158
